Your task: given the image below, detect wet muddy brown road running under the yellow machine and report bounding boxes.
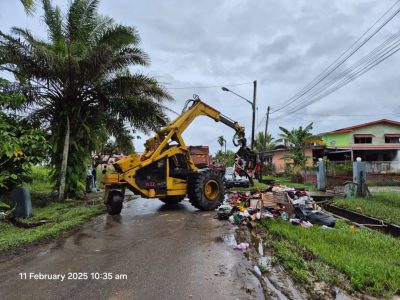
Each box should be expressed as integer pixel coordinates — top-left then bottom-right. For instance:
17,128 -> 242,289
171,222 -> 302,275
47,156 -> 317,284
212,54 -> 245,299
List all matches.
0,198 -> 264,300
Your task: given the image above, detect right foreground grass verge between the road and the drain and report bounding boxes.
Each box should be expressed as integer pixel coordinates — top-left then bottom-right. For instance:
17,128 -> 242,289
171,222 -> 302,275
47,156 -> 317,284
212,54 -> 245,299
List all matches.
261,220 -> 400,297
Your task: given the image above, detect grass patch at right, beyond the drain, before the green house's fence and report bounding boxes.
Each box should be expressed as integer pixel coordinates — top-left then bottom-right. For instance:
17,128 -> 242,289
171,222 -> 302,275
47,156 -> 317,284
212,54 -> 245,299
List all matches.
335,192 -> 400,225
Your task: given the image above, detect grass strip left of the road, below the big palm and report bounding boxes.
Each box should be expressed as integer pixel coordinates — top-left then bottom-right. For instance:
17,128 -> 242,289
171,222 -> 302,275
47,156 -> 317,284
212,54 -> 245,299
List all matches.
0,200 -> 104,252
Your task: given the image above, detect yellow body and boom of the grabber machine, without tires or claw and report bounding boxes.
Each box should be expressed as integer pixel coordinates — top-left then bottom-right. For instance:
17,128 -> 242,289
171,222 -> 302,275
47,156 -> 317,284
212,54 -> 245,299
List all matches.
102,99 -> 244,203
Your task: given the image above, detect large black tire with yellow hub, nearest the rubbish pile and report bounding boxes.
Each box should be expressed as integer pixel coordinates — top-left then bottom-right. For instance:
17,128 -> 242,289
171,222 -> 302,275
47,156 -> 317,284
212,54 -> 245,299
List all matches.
188,170 -> 225,210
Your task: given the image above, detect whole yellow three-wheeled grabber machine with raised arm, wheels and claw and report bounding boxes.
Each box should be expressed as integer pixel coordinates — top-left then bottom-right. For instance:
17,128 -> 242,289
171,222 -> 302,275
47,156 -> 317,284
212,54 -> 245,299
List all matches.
102,95 -> 255,215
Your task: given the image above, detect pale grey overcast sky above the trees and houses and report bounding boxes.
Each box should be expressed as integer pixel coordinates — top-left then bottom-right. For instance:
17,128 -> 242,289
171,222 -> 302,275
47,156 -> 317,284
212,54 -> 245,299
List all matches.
0,0 -> 400,153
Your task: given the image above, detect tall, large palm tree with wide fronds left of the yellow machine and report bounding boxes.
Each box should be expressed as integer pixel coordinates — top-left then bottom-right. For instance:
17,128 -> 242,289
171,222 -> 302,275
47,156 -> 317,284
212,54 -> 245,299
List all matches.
0,0 -> 171,199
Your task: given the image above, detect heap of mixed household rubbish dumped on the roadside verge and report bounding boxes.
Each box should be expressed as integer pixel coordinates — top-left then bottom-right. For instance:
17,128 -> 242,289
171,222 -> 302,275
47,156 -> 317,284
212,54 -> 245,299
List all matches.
217,185 -> 335,229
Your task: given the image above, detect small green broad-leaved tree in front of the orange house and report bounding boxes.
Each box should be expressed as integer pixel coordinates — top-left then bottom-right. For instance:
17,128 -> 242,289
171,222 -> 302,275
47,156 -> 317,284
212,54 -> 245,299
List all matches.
278,123 -> 313,182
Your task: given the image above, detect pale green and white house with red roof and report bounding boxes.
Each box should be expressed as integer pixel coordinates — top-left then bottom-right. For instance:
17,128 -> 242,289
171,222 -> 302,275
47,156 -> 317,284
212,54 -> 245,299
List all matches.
320,119 -> 400,161
